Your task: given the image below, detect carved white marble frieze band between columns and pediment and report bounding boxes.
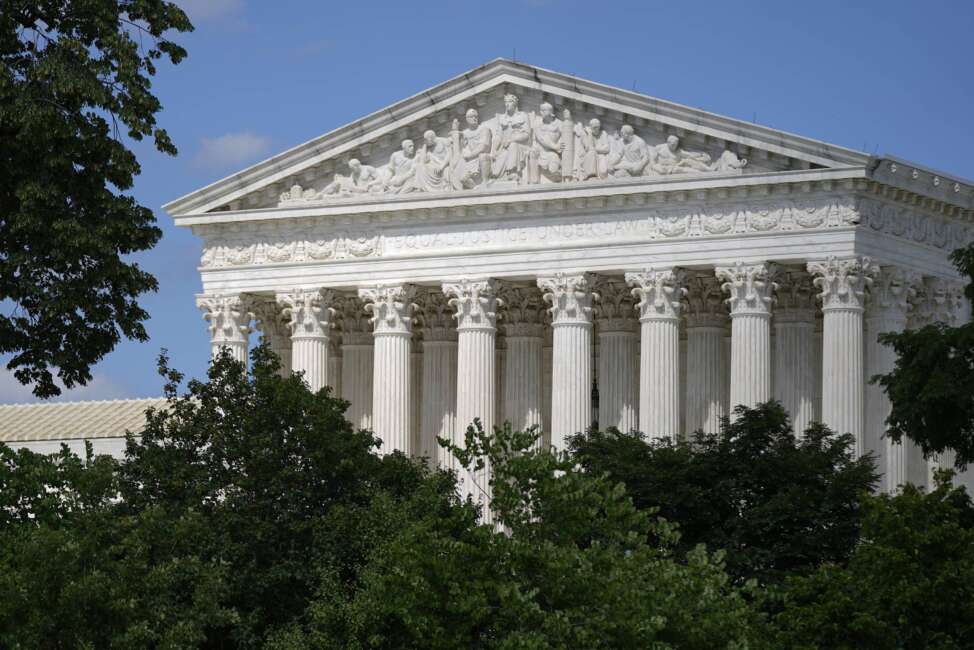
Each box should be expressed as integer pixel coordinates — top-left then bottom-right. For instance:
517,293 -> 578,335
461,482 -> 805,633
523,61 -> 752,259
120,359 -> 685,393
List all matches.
200,196 -> 974,268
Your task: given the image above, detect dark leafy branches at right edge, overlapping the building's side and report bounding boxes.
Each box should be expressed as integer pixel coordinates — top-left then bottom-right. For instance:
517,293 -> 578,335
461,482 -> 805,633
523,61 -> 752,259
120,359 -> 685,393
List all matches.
873,245 -> 974,468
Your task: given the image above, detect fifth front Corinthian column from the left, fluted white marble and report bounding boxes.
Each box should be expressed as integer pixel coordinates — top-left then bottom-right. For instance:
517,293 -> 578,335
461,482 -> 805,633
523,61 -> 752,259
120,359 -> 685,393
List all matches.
538,273 -> 595,450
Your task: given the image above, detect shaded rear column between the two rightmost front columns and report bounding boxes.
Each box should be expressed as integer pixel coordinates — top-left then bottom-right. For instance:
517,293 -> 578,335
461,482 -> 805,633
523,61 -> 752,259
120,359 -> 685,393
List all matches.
774,271 -> 815,436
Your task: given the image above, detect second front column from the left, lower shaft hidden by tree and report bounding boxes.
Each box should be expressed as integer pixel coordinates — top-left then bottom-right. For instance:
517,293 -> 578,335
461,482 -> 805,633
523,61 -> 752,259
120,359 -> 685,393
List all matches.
277,289 -> 335,392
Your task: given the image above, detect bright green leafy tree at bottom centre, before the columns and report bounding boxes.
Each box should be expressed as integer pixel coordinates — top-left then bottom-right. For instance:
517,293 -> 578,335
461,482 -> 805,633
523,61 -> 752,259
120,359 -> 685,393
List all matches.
271,424 -> 757,650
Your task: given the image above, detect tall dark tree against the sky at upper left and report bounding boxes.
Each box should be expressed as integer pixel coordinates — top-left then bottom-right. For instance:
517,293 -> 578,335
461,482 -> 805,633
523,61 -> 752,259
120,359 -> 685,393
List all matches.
0,0 -> 192,397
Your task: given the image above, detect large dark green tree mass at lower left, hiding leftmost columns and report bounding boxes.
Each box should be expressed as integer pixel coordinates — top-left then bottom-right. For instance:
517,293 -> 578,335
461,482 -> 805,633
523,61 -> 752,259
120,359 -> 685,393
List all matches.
0,348 -> 450,648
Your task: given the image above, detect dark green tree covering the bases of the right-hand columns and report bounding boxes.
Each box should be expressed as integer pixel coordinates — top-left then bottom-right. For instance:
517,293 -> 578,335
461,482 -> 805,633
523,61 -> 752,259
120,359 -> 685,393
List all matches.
570,401 -> 878,583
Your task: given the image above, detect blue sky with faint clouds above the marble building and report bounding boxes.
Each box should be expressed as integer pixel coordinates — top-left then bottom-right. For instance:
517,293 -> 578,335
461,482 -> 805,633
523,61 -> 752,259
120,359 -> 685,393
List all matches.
0,0 -> 974,403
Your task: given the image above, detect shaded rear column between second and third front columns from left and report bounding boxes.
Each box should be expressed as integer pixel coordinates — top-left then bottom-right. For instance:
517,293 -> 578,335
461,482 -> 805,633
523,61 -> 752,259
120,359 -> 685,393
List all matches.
338,296 -> 375,430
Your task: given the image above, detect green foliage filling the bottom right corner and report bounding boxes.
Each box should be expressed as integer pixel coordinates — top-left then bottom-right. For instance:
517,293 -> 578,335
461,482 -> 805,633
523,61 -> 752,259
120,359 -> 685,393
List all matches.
764,476 -> 974,650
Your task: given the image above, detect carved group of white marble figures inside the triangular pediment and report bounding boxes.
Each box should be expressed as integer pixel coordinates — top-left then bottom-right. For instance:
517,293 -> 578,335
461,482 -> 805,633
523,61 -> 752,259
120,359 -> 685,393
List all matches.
280,94 -> 747,204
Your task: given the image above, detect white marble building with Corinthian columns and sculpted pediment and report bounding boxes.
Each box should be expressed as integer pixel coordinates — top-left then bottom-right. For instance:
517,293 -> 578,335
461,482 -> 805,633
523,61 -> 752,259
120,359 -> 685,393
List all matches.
5,60 -> 974,486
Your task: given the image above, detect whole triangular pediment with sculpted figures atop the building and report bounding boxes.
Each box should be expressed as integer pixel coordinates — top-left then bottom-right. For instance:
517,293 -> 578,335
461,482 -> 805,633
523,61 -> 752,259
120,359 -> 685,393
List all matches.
165,60 -> 869,217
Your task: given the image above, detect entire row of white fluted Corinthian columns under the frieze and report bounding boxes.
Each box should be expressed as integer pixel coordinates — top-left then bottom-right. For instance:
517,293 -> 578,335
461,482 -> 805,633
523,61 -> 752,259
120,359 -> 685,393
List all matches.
200,258 -> 959,490
